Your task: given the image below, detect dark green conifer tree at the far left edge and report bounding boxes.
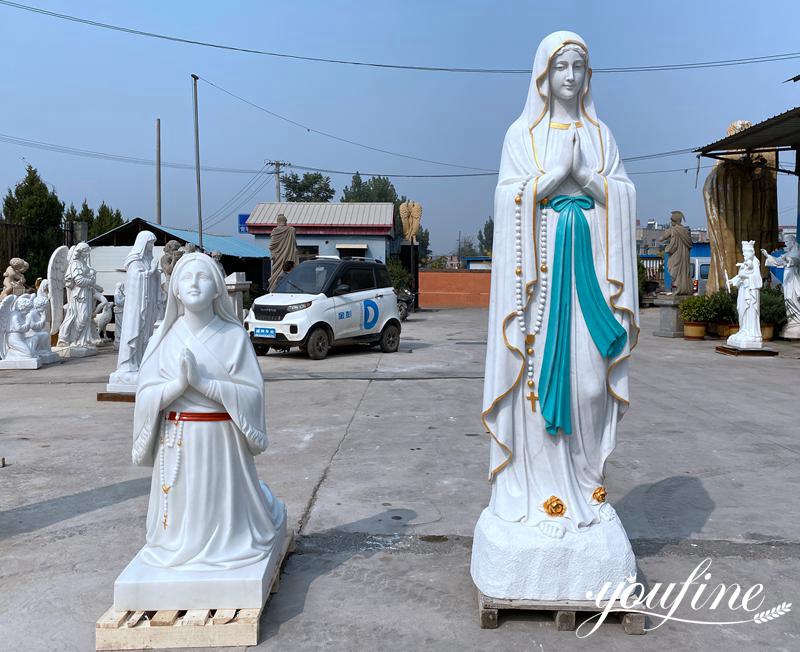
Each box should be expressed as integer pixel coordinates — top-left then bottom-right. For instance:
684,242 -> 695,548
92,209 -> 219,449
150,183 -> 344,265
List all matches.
3,165 -> 64,284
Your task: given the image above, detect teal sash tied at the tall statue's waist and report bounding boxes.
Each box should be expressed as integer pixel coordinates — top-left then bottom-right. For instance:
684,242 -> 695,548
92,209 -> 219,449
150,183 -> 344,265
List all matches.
539,195 -> 627,435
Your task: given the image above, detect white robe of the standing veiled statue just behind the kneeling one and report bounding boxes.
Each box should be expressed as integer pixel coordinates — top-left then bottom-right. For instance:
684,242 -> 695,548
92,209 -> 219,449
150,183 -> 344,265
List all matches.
116,258 -> 161,374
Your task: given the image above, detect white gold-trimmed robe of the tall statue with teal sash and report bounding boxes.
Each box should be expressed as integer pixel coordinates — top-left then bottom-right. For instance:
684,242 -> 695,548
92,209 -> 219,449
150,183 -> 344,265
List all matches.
483,108 -> 639,531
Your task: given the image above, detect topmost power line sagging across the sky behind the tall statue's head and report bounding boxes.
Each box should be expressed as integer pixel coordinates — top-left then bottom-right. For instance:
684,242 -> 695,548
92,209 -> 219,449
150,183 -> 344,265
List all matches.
0,0 -> 800,75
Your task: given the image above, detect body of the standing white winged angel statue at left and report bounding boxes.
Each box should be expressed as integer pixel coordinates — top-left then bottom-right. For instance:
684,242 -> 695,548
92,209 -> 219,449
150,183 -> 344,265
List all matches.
54,242 -> 97,355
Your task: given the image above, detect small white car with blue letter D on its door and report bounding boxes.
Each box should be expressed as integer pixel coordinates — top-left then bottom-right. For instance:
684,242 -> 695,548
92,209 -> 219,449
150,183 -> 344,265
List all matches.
245,258 -> 400,360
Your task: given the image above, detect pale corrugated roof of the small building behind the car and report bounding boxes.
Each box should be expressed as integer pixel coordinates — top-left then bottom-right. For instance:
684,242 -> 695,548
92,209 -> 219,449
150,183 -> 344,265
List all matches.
247,202 -> 394,228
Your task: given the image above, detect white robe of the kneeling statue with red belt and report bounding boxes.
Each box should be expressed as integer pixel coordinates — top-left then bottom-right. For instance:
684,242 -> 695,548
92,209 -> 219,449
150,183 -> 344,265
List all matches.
133,317 -> 285,570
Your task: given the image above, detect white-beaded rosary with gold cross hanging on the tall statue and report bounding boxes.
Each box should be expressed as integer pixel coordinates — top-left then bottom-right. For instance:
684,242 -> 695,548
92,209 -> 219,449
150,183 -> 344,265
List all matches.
514,175 -> 547,411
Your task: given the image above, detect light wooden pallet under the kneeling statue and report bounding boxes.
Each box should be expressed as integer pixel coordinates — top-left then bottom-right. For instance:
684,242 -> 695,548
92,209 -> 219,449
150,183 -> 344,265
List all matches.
95,530 -> 294,650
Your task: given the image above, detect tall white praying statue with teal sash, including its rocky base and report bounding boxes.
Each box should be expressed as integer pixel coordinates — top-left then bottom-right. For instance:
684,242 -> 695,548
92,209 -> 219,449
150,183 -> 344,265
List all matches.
471,32 -> 639,600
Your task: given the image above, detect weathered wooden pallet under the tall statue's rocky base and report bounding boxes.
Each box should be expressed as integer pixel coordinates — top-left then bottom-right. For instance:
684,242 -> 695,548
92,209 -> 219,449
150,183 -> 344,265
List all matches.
478,592 -> 645,634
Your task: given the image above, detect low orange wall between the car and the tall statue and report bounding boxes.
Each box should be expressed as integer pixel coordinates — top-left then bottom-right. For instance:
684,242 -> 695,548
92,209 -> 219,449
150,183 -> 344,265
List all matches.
419,269 -> 492,308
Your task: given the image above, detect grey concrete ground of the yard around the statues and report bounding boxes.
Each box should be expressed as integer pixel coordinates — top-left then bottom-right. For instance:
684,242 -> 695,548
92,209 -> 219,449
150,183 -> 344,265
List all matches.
0,310 -> 800,652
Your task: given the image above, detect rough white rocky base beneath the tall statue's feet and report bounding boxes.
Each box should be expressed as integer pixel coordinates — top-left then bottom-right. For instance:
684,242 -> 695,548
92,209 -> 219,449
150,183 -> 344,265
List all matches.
471,507 -> 636,601
